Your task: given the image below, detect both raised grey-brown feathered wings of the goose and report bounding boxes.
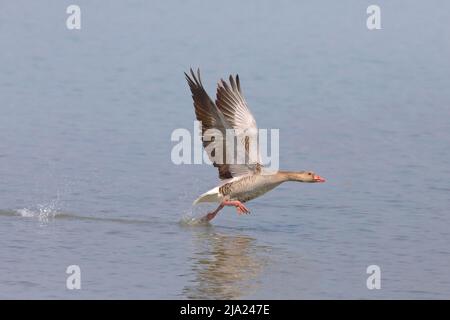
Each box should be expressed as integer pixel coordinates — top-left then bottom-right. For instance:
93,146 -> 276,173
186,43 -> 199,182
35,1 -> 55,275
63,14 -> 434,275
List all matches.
185,69 -> 261,179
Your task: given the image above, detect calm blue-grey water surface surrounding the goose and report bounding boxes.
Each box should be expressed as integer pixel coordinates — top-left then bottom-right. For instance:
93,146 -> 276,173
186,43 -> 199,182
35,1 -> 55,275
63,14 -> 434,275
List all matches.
0,0 -> 450,299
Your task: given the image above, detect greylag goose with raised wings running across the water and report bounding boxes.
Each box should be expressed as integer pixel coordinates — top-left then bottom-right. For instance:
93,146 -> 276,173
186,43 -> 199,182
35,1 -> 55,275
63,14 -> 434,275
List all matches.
184,69 -> 325,221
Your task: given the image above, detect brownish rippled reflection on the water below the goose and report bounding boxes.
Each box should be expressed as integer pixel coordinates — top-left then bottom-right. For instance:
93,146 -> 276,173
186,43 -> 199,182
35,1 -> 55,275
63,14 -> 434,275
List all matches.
183,228 -> 270,299
